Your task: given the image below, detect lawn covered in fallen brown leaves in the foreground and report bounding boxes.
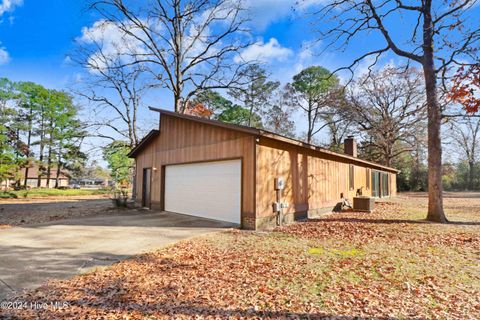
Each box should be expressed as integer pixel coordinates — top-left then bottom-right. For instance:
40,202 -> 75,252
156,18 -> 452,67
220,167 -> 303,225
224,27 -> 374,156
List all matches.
0,194 -> 480,319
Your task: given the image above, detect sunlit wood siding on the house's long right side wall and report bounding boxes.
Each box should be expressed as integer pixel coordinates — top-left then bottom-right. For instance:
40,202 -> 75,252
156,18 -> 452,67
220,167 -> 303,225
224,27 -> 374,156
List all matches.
256,138 -> 396,218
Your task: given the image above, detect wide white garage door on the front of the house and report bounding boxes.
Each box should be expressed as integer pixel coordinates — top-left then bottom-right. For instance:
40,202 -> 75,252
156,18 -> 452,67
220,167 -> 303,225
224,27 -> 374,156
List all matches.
165,160 -> 242,224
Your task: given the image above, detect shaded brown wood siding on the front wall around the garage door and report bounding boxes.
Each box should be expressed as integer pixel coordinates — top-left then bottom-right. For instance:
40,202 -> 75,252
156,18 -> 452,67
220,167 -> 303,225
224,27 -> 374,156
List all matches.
136,115 -> 255,226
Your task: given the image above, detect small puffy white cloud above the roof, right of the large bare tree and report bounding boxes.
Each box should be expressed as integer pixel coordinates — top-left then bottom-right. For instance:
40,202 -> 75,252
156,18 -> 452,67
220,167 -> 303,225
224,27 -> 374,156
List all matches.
234,38 -> 293,63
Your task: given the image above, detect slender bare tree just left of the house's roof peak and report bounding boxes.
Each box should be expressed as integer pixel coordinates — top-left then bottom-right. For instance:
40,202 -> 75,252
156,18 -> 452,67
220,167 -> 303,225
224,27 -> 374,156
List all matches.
71,21 -> 155,147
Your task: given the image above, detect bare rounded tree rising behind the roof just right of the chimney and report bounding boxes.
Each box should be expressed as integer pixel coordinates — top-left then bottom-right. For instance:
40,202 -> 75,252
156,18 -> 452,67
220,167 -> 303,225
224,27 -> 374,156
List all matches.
343,66 -> 426,166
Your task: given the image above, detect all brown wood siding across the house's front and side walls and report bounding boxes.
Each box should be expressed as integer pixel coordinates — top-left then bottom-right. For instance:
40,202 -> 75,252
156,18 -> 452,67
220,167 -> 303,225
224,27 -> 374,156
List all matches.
132,114 -> 396,229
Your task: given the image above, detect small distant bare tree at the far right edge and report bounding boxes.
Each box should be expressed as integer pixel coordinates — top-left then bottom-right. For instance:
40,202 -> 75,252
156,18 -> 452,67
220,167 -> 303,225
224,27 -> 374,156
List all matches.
450,116 -> 480,190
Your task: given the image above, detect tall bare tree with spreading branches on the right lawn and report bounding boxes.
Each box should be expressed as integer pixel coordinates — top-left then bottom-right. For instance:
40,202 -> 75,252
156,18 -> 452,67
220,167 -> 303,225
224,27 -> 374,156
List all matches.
317,0 -> 480,222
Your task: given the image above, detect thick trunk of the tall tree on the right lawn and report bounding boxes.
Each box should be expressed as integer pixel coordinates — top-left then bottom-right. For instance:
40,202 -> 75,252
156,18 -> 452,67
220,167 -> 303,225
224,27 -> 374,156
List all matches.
423,51 -> 447,223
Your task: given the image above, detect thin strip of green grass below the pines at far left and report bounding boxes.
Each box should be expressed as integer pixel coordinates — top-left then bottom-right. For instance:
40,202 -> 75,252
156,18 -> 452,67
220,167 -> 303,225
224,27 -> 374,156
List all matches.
0,189 -> 111,198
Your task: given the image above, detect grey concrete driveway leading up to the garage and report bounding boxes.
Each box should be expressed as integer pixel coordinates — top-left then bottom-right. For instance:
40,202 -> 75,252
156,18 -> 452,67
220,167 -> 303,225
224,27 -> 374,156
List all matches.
0,211 -> 232,301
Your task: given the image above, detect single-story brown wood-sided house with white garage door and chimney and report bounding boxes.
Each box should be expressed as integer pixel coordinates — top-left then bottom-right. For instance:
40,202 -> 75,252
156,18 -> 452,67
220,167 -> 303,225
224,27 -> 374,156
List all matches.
129,108 -> 398,230
